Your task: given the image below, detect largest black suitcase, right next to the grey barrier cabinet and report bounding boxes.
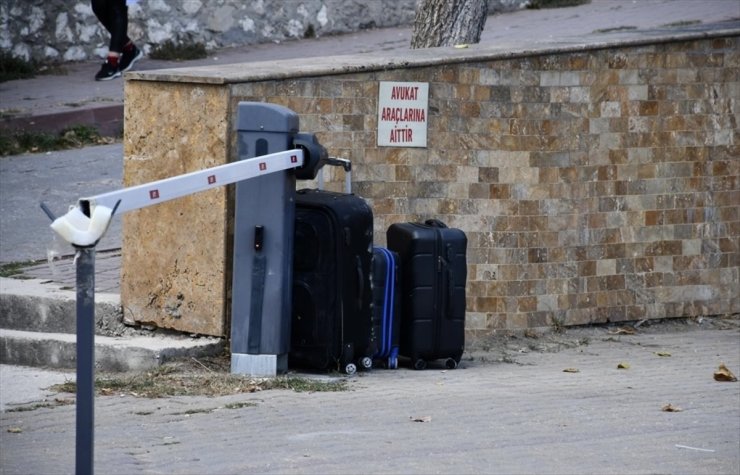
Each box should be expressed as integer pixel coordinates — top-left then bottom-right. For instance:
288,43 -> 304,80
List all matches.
288,182 -> 373,374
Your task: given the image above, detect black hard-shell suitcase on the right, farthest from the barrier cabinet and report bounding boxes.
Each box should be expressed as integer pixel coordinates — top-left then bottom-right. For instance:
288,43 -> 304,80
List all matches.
386,220 -> 467,369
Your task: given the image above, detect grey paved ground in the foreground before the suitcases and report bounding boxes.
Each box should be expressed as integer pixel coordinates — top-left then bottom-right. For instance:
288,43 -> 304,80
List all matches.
0,322 -> 740,475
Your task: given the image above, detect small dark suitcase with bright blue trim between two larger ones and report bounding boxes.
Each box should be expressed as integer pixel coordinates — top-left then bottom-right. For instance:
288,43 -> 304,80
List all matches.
372,247 -> 401,369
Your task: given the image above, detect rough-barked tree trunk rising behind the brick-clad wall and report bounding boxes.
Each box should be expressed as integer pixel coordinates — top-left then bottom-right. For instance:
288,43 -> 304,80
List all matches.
411,0 -> 488,48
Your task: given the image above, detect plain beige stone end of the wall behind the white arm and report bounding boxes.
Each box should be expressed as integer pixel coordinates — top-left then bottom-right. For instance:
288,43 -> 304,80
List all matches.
121,79 -> 233,336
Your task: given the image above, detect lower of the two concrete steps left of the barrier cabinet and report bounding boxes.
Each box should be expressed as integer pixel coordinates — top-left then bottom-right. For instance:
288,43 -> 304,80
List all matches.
0,329 -> 225,371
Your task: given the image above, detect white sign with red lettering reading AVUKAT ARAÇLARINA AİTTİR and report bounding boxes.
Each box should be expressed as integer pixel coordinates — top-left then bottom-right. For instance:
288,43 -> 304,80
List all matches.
378,82 -> 429,147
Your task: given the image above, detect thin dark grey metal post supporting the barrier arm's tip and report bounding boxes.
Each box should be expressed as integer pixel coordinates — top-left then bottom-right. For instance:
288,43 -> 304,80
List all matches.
75,246 -> 95,475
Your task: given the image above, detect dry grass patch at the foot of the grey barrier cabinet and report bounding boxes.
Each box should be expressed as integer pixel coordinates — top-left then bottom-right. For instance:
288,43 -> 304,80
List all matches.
50,362 -> 349,402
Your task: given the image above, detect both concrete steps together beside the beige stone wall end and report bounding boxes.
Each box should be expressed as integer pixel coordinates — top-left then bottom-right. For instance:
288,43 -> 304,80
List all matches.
0,278 -> 226,371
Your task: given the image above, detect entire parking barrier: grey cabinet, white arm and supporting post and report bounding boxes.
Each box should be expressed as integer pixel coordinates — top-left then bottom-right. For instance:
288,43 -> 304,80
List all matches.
41,102 -> 329,473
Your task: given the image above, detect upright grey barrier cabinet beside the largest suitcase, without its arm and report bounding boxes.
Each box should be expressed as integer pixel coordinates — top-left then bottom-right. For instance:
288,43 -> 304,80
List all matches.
231,102 -> 327,377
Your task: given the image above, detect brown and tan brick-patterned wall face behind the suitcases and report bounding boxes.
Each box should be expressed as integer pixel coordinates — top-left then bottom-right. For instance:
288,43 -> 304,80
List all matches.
124,35 -> 740,333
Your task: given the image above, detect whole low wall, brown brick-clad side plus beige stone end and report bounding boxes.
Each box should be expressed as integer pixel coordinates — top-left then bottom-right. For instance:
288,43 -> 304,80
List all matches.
122,32 -> 740,335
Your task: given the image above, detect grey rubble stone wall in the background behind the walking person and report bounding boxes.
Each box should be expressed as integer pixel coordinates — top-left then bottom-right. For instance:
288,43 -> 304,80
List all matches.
0,0 -> 526,61
